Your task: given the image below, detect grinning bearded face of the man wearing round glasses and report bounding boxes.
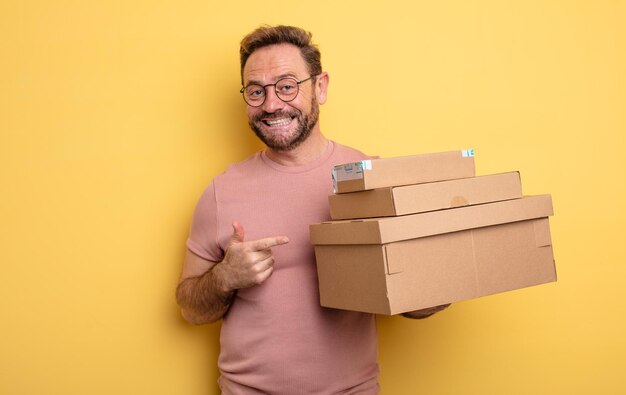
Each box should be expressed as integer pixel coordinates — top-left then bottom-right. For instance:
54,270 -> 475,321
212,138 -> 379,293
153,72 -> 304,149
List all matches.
243,44 -> 319,151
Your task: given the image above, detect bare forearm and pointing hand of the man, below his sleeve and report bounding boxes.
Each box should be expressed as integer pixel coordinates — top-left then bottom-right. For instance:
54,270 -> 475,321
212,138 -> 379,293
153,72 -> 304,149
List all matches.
176,222 -> 289,325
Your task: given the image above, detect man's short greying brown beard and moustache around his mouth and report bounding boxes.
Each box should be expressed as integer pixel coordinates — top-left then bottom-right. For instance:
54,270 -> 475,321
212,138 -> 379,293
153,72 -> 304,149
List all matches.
248,96 -> 320,152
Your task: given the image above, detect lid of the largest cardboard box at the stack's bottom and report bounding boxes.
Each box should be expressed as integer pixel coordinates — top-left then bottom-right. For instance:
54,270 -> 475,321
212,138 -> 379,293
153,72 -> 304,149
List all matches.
310,195 -> 553,245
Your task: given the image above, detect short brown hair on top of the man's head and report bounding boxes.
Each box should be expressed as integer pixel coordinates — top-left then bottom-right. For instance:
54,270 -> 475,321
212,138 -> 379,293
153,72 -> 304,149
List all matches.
239,25 -> 322,84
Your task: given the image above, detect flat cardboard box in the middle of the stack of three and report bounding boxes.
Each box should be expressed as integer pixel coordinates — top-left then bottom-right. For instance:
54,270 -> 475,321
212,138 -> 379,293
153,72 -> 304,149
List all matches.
328,172 -> 522,220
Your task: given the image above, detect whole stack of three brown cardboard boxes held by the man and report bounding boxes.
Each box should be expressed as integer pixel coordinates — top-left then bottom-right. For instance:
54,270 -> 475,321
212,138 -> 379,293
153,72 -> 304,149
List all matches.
310,150 -> 556,315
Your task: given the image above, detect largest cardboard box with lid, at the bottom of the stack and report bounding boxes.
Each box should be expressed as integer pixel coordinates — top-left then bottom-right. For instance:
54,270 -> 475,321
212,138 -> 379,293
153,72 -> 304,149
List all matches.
310,195 -> 556,315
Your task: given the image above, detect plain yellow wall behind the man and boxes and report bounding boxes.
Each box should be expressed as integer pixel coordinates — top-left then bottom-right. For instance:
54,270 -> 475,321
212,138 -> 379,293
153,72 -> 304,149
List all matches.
0,0 -> 626,394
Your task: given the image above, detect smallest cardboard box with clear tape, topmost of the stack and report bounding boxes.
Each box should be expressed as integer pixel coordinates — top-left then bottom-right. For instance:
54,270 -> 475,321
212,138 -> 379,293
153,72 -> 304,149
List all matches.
332,150 -> 476,193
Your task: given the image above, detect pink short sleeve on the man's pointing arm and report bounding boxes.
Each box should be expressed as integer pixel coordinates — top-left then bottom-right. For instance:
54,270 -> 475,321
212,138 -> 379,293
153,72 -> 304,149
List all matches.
187,182 -> 224,262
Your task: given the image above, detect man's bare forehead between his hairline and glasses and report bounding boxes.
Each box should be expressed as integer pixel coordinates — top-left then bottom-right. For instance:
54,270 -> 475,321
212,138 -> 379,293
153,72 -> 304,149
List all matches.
243,44 -> 308,85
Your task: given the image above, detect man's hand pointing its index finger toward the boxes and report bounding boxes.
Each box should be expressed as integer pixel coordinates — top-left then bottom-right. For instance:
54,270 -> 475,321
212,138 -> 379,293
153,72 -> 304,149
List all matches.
214,222 -> 289,291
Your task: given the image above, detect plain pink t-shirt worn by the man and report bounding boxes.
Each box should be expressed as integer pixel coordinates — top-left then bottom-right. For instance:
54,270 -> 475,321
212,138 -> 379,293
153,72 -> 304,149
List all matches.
187,142 -> 379,395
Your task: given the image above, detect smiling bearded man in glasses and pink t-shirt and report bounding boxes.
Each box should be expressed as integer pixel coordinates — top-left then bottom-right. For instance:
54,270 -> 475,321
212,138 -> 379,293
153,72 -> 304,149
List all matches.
177,26 -> 443,395
